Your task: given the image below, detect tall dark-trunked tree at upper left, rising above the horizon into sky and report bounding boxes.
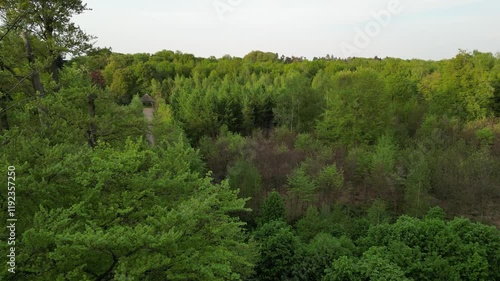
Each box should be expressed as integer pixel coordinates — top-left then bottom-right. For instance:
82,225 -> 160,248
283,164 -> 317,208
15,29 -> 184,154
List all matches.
0,0 -> 91,131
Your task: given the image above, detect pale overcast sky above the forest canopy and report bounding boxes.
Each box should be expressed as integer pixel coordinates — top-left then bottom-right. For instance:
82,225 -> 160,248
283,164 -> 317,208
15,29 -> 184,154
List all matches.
74,0 -> 500,60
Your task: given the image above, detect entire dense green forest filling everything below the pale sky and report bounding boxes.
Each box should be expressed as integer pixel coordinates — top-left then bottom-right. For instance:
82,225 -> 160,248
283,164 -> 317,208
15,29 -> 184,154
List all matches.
0,0 -> 500,281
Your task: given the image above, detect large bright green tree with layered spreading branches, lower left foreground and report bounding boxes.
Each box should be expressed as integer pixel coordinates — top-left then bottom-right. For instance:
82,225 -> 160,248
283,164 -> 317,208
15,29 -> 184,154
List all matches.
0,138 -> 252,280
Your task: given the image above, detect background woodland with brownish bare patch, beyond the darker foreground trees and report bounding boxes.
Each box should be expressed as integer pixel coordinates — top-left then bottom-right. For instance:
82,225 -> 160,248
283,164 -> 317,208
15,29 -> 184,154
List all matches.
72,49 -> 500,223
